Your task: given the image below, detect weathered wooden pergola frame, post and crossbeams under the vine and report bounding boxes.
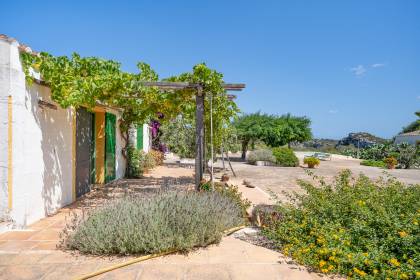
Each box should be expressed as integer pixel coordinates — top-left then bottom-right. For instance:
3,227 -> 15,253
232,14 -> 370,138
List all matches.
133,82 -> 245,190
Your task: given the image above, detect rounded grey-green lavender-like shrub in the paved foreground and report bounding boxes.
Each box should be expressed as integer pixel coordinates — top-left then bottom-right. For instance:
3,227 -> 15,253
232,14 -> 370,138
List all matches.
61,192 -> 244,255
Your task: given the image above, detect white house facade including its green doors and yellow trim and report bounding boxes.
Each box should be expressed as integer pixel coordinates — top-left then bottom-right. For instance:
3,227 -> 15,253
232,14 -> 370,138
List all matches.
0,36 -> 150,227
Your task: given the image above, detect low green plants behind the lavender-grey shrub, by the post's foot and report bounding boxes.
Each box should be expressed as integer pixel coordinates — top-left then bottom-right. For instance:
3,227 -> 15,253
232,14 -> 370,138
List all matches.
200,181 -> 251,217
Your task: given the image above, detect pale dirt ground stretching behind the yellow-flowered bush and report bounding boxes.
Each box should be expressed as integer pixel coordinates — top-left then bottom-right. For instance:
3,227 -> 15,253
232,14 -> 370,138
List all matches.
215,152 -> 420,198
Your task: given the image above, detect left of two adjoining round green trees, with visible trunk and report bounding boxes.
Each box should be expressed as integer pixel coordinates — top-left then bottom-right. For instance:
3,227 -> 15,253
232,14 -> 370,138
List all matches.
233,112 -> 273,159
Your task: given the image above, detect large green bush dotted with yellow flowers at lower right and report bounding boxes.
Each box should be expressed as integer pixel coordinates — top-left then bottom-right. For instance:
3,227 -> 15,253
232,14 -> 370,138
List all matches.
263,170 -> 420,279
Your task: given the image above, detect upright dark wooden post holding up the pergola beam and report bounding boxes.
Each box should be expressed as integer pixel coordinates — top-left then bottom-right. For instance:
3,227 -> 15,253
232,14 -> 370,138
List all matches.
195,86 -> 205,190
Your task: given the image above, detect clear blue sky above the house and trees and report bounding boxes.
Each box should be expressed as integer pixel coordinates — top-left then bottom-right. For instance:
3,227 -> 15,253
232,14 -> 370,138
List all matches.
0,0 -> 420,138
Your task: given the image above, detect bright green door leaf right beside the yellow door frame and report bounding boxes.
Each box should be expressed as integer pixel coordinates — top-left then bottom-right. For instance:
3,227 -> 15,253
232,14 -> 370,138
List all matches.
105,113 -> 117,183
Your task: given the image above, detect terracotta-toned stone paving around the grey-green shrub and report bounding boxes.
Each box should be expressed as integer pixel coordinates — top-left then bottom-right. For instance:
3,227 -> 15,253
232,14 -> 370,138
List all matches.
0,163 -> 334,280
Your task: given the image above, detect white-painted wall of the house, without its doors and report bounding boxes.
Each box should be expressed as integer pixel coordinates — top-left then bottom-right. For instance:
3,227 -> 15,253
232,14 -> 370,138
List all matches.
0,38 -> 126,227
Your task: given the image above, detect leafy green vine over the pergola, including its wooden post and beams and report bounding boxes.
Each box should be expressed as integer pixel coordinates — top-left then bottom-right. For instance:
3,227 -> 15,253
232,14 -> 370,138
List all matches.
21,51 -> 245,188
